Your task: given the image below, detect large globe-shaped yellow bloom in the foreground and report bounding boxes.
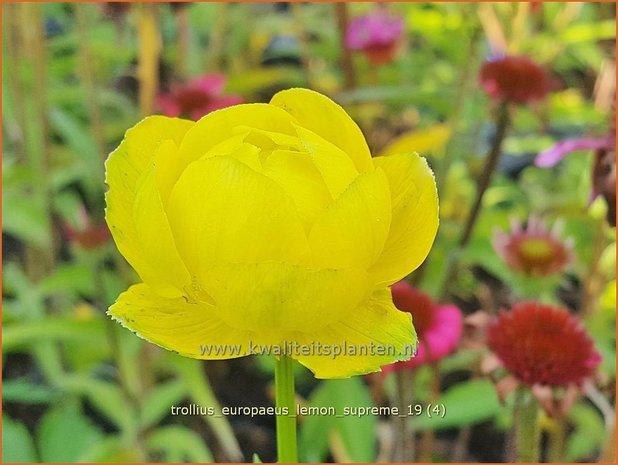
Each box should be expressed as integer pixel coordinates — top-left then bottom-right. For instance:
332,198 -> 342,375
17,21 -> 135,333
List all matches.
106,89 -> 438,378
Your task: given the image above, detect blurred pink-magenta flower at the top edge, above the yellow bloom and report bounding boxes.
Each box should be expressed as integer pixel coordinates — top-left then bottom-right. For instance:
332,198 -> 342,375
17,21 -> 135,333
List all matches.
346,11 -> 403,65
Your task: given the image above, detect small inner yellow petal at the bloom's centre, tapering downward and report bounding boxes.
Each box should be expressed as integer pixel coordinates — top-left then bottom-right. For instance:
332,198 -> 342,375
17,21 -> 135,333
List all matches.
264,150 -> 333,227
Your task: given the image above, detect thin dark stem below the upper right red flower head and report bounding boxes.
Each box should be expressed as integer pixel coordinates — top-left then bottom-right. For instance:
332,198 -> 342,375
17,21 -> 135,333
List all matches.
440,102 -> 509,300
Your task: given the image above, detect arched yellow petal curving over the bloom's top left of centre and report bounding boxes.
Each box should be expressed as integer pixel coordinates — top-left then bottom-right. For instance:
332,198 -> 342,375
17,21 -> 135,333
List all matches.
175,103 -> 296,177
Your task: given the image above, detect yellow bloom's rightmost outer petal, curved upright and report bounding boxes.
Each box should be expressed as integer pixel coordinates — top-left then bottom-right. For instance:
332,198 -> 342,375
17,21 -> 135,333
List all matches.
370,154 -> 438,285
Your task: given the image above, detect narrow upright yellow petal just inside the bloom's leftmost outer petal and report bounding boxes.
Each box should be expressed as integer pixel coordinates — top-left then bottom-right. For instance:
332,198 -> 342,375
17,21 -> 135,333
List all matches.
133,165 -> 191,297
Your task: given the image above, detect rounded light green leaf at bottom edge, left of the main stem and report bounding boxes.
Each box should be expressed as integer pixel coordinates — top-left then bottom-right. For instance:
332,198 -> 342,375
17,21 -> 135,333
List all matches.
146,425 -> 213,463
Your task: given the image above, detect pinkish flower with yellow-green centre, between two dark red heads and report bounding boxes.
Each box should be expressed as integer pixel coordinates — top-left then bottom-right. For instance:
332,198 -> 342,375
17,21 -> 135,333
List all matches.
492,216 -> 573,276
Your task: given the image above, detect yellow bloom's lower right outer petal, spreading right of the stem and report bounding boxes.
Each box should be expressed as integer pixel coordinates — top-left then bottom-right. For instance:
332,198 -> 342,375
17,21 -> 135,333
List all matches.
293,288 -> 416,378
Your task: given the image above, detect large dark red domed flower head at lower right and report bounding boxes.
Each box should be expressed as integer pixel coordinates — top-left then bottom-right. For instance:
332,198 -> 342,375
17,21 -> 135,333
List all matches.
487,302 -> 601,386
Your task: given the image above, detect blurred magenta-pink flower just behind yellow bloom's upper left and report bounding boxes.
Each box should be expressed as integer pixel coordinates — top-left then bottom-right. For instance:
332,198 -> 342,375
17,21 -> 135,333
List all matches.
156,74 -> 244,120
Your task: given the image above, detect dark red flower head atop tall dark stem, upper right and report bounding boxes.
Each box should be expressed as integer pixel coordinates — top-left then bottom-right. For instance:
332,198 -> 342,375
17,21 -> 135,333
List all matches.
479,56 -> 551,104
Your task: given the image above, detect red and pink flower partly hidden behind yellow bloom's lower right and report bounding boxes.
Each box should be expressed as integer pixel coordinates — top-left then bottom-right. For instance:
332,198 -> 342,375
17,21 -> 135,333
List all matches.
384,281 -> 463,371
